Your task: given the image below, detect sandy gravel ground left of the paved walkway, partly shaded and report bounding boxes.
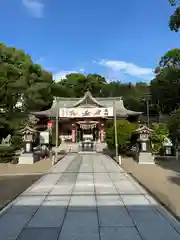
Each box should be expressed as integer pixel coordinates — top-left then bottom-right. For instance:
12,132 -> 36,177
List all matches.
0,160 -> 52,209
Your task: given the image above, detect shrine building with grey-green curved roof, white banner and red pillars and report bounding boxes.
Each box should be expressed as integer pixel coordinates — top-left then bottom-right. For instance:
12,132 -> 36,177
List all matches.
33,92 -> 141,143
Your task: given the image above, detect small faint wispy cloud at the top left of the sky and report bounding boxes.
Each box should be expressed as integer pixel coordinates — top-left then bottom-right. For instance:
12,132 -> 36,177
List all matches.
22,0 -> 44,18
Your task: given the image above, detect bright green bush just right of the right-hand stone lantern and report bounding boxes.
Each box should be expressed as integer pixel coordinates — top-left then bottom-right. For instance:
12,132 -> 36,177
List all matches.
151,123 -> 169,153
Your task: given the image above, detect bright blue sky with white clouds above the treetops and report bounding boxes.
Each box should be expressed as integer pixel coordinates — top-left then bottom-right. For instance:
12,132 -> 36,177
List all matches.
0,0 -> 180,82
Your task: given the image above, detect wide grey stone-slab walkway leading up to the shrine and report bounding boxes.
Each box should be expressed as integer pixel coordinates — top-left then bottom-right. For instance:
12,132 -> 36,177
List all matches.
0,154 -> 180,240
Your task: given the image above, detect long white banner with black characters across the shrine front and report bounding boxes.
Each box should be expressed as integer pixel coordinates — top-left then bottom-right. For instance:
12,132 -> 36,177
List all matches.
59,107 -> 113,118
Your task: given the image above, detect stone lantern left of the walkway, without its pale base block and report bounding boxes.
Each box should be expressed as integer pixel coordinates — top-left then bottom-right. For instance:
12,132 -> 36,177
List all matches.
20,125 -> 37,153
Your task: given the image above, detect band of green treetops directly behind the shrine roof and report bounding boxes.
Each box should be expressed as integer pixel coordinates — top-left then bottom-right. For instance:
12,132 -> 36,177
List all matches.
52,73 -> 150,112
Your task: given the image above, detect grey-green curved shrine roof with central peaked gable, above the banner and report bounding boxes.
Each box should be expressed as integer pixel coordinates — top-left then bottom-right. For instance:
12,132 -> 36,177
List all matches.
32,91 -> 142,117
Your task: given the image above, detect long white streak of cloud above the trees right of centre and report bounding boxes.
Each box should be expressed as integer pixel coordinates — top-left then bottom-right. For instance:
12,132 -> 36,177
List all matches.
94,59 -> 154,80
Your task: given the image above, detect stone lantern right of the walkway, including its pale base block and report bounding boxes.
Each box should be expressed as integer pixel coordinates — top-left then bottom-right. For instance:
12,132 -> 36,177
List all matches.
135,125 -> 154,163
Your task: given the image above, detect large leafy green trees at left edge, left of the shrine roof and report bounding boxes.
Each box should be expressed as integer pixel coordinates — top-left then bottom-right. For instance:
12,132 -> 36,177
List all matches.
0,43 -> 53,141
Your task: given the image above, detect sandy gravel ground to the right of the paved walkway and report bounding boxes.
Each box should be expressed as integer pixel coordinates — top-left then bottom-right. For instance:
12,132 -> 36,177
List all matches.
122,158 -> 180,220
